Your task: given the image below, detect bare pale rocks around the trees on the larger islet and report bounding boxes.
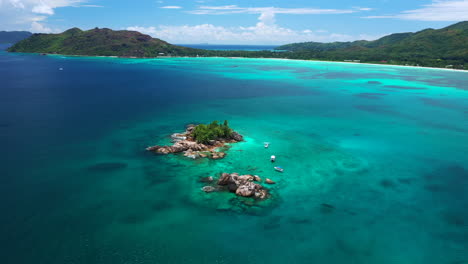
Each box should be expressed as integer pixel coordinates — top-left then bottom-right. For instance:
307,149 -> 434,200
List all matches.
146,125 -> 244,159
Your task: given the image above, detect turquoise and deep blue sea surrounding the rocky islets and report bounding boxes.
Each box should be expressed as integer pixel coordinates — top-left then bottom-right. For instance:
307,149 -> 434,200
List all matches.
0,52 -> 468,264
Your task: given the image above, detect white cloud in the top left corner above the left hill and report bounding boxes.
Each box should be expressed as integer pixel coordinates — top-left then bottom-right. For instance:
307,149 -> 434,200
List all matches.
0,0 -> 100,32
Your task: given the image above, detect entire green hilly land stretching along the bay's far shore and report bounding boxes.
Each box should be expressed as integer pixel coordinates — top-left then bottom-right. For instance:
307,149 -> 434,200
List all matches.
8,21 -> 468,70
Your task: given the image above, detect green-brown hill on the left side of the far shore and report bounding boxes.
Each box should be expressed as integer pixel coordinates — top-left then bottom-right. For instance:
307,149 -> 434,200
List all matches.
8,28 -> 197,57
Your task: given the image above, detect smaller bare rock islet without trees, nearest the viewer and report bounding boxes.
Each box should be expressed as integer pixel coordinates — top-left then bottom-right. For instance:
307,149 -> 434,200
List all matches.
201,173 -> 274,200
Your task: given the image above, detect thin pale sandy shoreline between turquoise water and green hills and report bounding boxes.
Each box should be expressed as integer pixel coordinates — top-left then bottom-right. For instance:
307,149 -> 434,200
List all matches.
5,51 -> 468,73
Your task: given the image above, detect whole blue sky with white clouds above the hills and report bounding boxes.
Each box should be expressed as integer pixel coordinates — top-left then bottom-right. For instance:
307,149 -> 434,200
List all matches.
0,0 -> 468,45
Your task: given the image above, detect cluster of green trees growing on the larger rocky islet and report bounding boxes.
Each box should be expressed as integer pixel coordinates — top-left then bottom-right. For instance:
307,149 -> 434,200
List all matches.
192,120 -> 233,144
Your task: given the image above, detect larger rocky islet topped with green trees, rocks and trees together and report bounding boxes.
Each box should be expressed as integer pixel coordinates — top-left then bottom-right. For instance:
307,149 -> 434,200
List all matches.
146,120 -> 244,159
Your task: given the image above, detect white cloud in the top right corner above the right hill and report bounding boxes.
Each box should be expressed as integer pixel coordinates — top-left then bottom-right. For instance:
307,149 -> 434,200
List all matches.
364,0 -> 468,21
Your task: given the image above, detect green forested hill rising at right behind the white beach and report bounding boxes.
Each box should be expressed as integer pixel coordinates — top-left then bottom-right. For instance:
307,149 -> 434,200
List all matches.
277,21 -> 468,67
